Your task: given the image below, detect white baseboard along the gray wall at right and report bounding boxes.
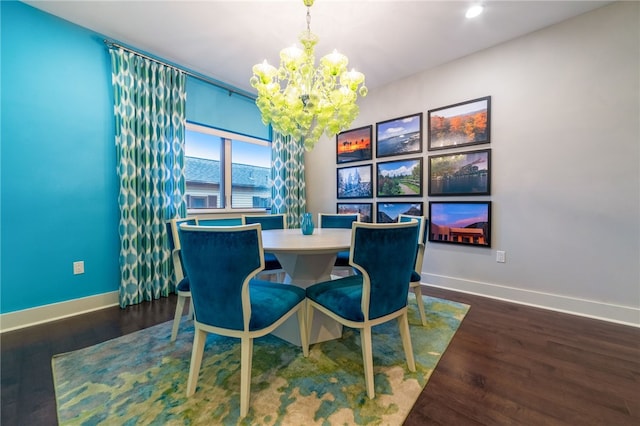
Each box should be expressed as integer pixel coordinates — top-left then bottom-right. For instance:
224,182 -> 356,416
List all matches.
421,272 -> 640,327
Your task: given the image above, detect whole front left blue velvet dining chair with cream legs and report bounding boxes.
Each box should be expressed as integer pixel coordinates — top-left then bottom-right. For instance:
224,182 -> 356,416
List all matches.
179,223 -> 309,417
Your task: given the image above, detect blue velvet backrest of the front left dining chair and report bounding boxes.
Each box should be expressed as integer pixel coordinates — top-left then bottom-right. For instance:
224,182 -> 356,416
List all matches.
179,223 -> 264,331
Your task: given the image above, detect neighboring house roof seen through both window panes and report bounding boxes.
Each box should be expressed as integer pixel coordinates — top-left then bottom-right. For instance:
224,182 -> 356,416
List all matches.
184,157 -> 271,187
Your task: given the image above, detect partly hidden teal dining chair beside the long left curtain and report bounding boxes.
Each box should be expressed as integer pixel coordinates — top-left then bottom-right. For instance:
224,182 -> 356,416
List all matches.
166,217 -> 198,342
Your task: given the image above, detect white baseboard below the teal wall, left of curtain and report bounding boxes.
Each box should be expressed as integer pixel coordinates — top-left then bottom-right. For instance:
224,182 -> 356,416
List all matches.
0,291 -> 118,333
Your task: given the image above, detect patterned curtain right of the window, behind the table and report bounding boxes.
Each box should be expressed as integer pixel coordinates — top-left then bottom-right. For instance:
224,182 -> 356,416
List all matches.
271,133 -> 307,228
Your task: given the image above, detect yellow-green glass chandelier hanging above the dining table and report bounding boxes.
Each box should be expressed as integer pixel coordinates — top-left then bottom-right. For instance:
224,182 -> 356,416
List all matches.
250,0 -> 367,150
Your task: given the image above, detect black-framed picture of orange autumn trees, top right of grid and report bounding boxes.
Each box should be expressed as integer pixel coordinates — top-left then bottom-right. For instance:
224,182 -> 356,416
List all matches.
427,96 -> 491,151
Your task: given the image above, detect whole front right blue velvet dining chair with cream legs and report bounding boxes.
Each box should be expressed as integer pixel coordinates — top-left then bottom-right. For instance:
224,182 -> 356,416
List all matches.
307,221 -> 418,398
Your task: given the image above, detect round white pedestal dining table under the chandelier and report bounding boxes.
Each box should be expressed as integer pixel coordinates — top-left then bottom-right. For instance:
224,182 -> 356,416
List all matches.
262,228 -> 351,346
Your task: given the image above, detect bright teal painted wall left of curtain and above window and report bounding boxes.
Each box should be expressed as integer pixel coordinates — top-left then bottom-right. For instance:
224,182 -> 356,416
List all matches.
0,1 -> 268,313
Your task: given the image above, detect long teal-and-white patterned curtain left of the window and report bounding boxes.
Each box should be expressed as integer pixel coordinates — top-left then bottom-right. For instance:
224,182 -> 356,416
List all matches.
109,47 -> 187,308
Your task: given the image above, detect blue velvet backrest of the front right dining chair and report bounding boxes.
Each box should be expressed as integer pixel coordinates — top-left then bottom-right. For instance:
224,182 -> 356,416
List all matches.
349,221 -> 418,319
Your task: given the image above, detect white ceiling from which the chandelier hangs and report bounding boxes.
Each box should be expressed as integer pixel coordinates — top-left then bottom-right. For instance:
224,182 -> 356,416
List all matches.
24,0 -> 610,93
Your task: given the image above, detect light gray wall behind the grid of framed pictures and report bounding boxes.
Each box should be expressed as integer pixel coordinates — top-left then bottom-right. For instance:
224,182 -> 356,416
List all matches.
306,2 -> 640,325
